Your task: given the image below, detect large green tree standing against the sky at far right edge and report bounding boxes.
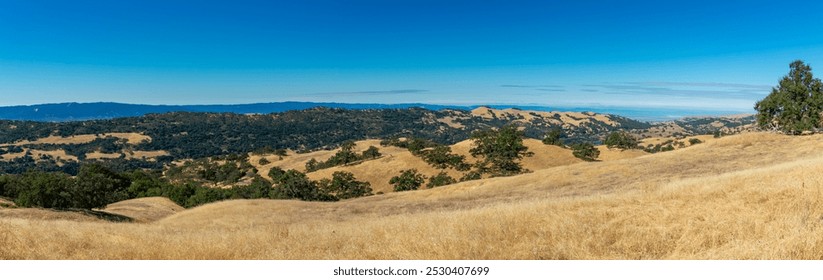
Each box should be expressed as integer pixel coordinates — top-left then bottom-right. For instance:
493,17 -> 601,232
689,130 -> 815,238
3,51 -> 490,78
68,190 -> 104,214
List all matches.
754,60 -> 823,134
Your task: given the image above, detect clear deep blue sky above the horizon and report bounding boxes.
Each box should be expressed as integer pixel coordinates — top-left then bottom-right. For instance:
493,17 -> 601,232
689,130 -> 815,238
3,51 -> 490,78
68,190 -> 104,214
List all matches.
0,0 -> 823,111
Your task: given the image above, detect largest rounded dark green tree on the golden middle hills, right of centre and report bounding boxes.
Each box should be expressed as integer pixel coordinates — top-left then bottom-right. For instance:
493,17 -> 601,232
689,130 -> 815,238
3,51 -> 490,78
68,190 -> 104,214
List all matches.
469,125 -> 532,176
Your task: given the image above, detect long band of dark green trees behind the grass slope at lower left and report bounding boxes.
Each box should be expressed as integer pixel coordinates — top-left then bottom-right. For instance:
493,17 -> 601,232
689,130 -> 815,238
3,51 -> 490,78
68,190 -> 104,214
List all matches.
0,161 -> 372,209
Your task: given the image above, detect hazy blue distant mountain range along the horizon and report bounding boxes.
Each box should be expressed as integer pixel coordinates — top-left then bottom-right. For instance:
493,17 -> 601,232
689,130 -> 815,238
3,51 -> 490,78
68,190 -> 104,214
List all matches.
0,101 -> 752,122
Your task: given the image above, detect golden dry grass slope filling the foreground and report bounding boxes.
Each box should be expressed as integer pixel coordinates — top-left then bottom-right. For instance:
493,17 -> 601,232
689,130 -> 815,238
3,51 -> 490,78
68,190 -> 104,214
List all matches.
0,133 -> 823,259
